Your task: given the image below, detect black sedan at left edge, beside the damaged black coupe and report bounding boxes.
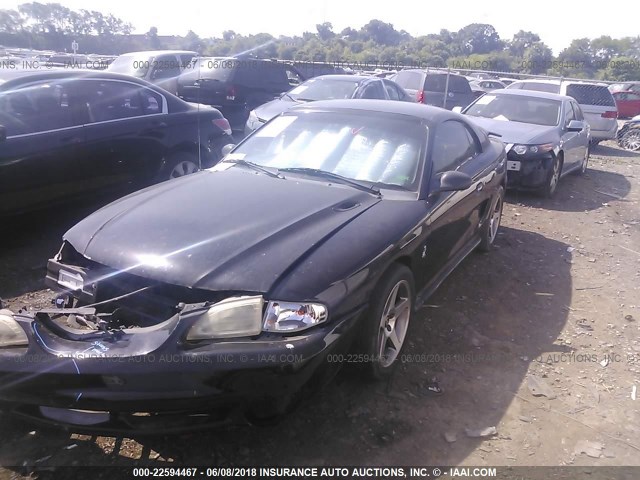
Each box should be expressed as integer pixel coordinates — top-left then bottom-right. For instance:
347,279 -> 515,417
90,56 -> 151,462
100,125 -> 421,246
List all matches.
0,70 -> 231,215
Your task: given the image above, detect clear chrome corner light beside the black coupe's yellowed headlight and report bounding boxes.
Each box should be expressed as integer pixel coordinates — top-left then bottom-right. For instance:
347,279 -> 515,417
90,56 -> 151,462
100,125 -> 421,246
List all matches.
262,302 -> 327,332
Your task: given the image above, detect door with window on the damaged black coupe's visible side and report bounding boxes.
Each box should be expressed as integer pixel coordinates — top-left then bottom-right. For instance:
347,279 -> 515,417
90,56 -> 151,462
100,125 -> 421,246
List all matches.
418,120 -> 485,285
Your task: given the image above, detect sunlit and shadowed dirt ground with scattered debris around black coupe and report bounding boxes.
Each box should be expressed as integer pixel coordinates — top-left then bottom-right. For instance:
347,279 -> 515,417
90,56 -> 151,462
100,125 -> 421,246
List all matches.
0,143 -> 640,478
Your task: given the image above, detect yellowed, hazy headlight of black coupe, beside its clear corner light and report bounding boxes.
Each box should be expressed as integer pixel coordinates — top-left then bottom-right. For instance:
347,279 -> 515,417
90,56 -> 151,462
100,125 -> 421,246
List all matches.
187,296 -> 264,340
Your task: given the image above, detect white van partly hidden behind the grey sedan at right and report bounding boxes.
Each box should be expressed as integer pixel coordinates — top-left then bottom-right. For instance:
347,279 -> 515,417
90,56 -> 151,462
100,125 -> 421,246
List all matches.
507,80 -> 618,144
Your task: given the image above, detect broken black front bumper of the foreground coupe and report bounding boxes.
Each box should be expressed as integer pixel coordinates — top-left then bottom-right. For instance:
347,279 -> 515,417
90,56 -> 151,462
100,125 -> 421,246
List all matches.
0,305 -> 360,433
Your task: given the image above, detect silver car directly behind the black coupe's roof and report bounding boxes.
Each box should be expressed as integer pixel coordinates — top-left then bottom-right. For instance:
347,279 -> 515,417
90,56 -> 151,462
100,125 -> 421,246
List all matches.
245,75 -> 414,135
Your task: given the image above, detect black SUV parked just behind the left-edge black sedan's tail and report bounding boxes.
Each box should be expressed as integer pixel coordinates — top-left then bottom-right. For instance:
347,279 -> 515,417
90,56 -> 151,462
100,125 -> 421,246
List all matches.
178,57 -> 306,131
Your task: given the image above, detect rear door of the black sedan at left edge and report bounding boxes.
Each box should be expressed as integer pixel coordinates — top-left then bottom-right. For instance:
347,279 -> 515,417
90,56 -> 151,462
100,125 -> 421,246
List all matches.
79,79 -> 170,191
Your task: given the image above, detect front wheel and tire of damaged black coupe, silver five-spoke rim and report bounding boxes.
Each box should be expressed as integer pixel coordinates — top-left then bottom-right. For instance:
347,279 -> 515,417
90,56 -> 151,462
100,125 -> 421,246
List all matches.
356,265 -> 415,380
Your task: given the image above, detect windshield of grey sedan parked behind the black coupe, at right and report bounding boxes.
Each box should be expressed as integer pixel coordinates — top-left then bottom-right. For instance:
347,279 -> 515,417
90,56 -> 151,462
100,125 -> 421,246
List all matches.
465,94 -> 560,127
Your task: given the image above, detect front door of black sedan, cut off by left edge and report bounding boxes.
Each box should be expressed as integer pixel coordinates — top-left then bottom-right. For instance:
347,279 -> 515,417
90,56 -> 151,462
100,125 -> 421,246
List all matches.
0,79 -> 84,214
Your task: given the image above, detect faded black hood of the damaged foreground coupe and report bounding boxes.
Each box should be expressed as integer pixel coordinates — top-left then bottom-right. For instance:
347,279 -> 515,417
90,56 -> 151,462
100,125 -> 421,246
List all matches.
65,171 -> 380,292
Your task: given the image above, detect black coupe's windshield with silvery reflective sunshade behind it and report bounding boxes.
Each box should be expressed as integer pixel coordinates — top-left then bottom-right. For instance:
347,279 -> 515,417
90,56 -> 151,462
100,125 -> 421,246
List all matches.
228,112 -> 428,191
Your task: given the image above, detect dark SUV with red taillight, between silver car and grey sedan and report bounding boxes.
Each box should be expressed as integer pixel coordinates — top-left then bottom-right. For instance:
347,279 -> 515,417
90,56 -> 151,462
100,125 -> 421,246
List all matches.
389,69 -> 476,110
